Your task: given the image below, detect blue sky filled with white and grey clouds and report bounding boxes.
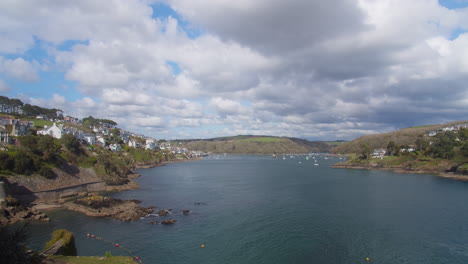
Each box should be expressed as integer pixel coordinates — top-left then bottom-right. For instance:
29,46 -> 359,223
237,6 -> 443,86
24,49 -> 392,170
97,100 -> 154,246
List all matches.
0,0 -> 468,140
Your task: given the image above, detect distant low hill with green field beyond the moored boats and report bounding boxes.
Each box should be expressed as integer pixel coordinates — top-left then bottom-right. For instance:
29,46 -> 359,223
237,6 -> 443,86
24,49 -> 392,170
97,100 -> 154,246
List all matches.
173,135 -> 333,154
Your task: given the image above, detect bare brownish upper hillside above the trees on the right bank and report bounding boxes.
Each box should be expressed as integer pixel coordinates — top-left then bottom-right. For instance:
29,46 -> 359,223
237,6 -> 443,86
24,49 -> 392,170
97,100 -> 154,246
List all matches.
330,121 -> 468,154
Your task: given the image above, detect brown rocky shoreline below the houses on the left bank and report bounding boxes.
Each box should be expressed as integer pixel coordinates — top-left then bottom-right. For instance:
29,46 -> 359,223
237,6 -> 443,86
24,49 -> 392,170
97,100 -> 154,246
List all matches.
0,158 -> 199,225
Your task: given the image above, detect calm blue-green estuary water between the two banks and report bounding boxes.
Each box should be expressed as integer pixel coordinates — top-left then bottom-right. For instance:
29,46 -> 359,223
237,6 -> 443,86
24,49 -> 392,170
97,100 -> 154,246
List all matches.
26,156 -> 468,264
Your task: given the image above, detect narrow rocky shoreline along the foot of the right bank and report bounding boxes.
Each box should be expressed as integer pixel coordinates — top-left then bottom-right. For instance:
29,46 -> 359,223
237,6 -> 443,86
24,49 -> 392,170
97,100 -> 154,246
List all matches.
332,163 -> 468,181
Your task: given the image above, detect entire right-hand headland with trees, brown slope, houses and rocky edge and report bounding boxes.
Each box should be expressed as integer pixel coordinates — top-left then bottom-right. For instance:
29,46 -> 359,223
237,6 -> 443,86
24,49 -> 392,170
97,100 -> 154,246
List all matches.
332,121 -> 468,181
